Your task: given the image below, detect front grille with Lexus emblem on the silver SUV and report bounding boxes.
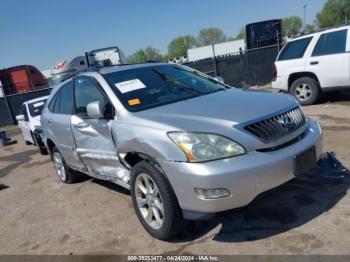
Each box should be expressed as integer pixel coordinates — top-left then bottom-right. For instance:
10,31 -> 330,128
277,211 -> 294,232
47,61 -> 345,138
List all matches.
245,107 -> 305,142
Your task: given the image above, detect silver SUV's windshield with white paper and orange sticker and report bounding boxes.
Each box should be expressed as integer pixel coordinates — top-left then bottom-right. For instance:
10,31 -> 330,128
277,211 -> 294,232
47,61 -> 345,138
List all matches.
104,65 -> 228,112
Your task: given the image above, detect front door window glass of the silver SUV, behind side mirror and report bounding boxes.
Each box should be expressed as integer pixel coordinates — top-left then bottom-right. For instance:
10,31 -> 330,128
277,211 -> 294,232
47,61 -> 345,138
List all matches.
74,77 -> 110,116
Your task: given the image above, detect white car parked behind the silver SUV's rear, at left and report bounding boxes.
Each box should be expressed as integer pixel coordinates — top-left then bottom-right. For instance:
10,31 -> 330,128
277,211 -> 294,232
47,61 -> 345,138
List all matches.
16,96 -> 48,154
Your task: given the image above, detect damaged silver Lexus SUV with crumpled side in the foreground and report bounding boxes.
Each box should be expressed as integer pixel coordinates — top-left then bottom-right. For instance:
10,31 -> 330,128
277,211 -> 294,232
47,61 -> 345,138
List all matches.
41,63 -> 322,239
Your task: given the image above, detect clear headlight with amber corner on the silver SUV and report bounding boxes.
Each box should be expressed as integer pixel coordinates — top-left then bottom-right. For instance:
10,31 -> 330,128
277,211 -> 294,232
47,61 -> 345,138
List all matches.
168,132 -> 245,162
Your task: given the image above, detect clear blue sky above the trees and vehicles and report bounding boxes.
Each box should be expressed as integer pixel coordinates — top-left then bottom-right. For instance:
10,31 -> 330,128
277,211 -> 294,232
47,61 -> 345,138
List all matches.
0,0 -> 326,70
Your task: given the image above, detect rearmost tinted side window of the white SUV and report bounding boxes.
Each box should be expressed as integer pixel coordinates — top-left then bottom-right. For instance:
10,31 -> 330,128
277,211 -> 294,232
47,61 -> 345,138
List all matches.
278,37 -> 312,61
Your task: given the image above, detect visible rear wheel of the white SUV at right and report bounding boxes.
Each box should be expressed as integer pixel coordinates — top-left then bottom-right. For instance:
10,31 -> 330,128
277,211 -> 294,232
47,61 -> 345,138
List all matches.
290,77 -> 321,106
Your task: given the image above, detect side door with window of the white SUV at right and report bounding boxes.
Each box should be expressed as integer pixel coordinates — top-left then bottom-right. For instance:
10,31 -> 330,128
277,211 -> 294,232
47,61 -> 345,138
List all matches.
305,29 -> 350,88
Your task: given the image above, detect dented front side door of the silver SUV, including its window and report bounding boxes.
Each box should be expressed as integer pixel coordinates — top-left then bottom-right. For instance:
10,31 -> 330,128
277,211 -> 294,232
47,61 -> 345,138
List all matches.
71,77 -> 127,182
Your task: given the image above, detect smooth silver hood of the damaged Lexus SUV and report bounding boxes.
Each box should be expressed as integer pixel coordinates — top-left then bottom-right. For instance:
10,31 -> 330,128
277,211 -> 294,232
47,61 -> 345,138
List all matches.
135,89 -> 298,130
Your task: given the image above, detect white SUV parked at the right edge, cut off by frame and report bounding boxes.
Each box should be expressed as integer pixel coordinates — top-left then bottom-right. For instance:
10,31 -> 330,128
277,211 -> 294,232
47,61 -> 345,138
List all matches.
272,26 -> 350,105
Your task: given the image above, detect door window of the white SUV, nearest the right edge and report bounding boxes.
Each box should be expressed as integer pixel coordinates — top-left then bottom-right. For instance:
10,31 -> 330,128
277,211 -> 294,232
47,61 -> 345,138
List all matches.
312,29 -> 348,56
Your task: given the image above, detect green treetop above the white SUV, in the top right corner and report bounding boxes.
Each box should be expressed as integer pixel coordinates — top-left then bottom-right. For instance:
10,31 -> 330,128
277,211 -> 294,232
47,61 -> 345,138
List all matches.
316,0 -> 350,28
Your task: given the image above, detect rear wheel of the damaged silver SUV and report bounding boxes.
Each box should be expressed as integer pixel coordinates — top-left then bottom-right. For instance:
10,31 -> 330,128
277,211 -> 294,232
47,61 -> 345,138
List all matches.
51,147 -> 77,184
